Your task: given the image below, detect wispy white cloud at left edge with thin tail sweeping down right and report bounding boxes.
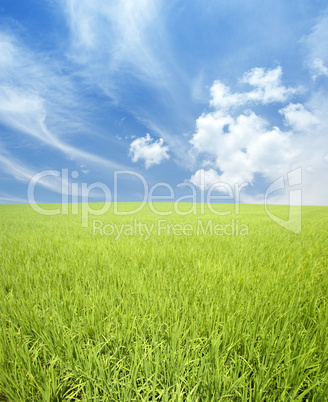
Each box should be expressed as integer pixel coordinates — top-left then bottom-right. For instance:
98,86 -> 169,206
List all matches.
0,32 -> 127,174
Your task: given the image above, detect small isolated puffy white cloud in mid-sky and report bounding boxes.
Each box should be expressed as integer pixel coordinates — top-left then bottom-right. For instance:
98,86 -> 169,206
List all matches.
130,134 -> 170,169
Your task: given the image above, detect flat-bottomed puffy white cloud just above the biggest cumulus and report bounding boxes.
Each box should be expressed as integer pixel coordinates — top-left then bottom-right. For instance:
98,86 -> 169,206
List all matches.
210,66 -> 297,109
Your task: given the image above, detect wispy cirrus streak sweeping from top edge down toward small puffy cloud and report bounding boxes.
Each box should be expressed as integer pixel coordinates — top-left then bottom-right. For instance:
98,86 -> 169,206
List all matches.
60,0 -> 194,169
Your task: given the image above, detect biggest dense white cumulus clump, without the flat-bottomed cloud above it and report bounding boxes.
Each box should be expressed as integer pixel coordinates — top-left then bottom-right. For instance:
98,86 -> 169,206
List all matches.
190,112 -> 295,186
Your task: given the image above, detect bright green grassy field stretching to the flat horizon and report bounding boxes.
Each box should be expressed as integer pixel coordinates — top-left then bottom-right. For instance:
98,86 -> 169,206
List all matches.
0,204 -> 328,402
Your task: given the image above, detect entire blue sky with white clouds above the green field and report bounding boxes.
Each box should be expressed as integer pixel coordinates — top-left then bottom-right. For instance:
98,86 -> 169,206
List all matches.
0,0 -> 328,205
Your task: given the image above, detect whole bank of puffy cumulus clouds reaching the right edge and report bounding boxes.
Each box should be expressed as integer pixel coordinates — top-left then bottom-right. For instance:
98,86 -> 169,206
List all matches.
190,67 -> 328,205
